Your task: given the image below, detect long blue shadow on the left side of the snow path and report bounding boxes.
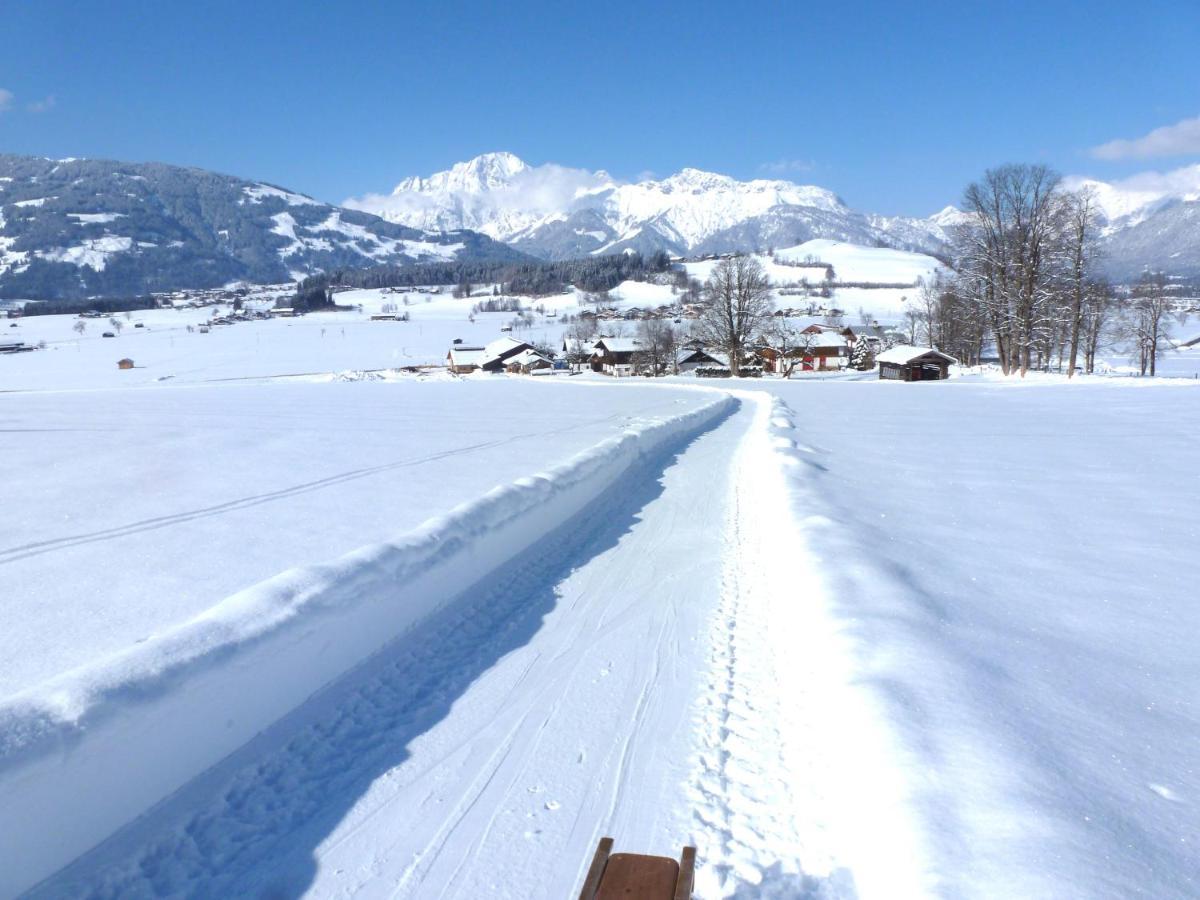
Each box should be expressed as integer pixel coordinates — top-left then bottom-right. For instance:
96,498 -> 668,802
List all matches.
30,407 -> 736,898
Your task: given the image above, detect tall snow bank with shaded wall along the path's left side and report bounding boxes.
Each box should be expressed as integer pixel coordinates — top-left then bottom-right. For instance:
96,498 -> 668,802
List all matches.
0,395 -> 737,895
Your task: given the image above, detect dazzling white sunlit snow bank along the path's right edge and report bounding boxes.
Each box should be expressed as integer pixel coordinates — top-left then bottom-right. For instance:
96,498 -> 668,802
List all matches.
736,394 -> 938,899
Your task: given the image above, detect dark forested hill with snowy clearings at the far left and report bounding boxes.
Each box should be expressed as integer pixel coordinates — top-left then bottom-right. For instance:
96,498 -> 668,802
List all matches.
0,155 -> 527,300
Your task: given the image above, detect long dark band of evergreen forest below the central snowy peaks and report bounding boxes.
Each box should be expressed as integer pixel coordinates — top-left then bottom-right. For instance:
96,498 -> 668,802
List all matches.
296,251 -> 671,302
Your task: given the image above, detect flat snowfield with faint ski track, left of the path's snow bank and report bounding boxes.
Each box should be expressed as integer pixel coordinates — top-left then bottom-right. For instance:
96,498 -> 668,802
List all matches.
0,379 -> 702,697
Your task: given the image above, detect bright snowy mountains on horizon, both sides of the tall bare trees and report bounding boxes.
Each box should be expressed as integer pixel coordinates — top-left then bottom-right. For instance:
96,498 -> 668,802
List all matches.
346,152 -> 1200,278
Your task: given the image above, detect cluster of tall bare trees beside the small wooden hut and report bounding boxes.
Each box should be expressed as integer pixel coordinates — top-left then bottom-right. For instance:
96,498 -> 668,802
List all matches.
905,164 -> 1183,376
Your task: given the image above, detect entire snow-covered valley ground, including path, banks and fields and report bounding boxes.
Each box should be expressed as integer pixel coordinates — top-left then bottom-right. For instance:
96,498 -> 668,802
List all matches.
0,248 -> 1200,900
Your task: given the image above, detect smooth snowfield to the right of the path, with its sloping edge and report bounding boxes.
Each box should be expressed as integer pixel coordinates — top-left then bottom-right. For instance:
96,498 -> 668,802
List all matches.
758,379 -> 1200,898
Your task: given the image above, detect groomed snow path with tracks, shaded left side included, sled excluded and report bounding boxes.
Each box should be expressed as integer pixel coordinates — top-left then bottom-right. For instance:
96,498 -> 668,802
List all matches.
35,395 -> 883,900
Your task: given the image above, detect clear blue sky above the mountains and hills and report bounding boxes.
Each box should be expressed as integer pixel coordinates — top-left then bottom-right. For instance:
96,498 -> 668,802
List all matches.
0,0 -> 1200,215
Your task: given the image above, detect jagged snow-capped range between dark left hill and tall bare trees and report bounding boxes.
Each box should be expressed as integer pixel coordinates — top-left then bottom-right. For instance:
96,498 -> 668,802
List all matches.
346,152 -> 950,259
